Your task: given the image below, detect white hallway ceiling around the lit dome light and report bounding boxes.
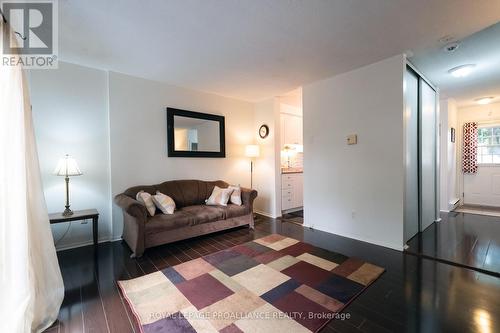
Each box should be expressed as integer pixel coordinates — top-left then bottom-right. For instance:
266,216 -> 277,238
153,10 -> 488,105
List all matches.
411,23 -> 500,107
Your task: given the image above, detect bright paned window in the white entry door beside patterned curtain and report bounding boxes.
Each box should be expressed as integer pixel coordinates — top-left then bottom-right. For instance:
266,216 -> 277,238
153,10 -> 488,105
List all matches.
477,125 -> 500,164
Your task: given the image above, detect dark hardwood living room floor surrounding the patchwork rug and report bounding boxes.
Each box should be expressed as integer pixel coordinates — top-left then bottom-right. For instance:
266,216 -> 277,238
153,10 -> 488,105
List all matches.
44,216 -> 500,333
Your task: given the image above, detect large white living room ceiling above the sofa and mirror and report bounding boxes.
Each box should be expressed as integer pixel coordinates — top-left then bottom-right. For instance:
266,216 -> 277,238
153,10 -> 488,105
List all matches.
59,0 -> 500,101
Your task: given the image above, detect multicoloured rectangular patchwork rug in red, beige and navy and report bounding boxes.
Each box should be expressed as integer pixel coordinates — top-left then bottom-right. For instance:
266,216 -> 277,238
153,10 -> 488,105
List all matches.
118,234 -> 384,333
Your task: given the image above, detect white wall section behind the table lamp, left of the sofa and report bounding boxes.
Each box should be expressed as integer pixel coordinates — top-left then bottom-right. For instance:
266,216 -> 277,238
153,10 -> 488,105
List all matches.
29,62 -> 111,248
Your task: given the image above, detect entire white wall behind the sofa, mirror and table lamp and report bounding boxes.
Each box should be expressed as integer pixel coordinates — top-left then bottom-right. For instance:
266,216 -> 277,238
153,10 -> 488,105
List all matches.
29,62 -> 255,249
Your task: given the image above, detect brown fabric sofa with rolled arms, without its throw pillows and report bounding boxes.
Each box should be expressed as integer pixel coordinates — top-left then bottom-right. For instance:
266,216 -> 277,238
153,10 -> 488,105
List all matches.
115,180 -> 257,257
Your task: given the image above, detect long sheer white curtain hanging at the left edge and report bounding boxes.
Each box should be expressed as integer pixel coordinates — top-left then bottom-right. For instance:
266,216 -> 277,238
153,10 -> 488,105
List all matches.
0,20 -> 64,333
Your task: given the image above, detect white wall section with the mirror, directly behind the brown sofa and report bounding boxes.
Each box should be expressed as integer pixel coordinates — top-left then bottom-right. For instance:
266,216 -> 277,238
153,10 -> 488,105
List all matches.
109,72 -> 259,238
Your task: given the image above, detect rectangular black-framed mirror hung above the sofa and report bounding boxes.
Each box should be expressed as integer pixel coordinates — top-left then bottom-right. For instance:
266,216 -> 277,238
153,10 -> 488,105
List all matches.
167,108 -> 226,157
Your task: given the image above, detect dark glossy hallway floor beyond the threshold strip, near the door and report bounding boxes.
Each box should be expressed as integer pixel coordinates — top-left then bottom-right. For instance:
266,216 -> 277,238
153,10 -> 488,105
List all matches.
406,212 -> 500,276
